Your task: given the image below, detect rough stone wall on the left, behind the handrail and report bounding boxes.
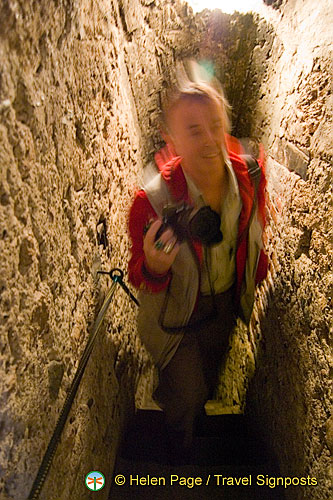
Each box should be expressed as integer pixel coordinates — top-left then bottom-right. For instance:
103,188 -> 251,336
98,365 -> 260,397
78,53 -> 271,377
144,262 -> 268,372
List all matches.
0,0 -> 200,500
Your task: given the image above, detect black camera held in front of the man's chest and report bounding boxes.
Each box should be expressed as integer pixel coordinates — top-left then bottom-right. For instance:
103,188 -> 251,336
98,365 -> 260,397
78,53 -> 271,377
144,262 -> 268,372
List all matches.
155,203 -> 222,246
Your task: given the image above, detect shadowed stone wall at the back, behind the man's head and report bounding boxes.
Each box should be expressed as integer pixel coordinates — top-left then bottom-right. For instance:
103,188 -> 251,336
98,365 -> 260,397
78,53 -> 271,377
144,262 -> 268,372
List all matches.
198,10 -> 273,137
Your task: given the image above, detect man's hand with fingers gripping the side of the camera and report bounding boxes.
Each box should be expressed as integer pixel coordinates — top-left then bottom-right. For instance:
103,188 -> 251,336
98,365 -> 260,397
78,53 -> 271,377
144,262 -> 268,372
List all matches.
143,219 -> 180,274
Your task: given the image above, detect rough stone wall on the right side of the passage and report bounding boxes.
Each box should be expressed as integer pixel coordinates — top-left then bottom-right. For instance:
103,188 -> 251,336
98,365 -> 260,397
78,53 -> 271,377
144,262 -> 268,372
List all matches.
237,0 -> 333,500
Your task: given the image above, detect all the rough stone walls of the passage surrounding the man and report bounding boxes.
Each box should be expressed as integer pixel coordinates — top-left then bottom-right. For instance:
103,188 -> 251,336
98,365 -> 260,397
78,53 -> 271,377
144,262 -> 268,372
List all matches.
0,0 -> 332,500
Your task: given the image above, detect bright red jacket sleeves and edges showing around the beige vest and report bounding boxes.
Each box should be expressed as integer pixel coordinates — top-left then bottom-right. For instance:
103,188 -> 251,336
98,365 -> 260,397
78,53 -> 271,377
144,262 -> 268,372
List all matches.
128,137 -> 267,306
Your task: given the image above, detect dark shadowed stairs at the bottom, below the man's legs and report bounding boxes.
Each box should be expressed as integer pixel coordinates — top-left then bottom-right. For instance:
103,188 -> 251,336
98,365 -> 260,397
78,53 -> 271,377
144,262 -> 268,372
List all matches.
109,410 -> 285,500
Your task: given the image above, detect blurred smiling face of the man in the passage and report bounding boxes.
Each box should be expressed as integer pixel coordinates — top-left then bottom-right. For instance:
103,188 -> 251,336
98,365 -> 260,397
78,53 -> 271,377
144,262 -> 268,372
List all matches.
168,97 -> 225,175
